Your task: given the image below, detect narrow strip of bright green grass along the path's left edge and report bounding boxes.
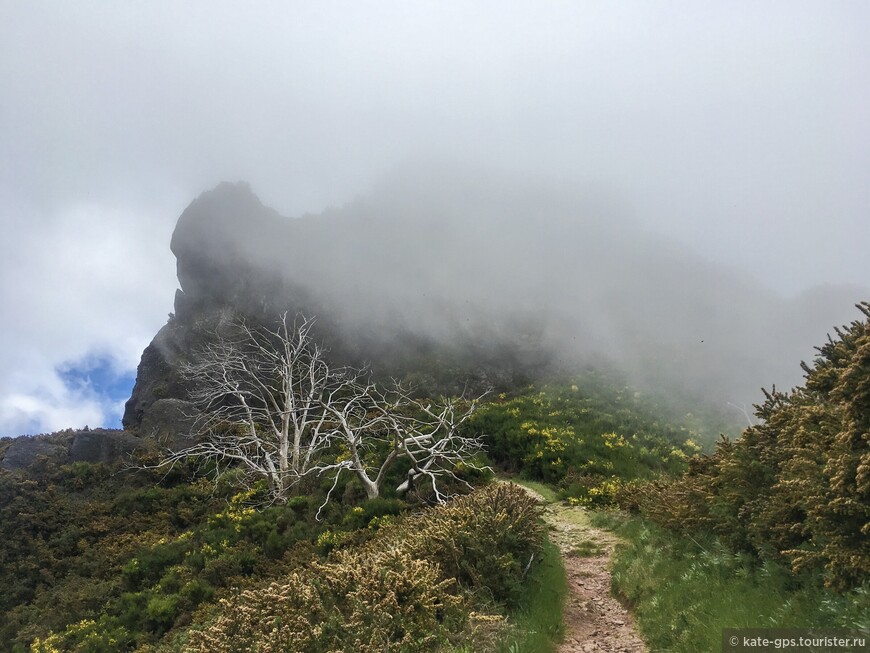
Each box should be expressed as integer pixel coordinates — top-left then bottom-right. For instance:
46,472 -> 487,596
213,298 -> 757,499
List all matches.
496,538 -> 568,653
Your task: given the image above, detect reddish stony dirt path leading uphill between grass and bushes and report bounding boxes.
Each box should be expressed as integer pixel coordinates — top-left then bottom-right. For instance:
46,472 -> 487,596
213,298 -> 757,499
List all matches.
516,482 -> 647,653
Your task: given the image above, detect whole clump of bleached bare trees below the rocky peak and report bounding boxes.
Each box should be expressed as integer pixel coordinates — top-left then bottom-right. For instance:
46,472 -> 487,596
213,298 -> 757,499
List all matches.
152,314 -> 482,502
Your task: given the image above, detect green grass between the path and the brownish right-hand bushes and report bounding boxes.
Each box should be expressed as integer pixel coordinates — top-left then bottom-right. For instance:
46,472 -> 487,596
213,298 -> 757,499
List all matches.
592,513 -> 870,653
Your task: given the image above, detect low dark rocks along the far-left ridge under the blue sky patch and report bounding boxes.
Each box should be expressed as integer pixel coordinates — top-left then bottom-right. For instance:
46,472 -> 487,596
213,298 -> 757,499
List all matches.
0,429 -> 150,470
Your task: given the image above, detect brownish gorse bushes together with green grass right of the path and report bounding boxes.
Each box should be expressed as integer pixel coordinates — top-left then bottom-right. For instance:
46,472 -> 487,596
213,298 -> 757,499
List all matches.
598,303 -> 870,652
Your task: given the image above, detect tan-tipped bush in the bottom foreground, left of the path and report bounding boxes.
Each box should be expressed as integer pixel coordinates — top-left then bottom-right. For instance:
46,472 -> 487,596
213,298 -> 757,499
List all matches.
187,547 -> 468,653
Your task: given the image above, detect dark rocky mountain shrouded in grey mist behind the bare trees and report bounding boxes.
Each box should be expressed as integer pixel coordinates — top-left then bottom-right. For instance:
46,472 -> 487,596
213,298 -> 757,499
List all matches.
124,166 -> 866,430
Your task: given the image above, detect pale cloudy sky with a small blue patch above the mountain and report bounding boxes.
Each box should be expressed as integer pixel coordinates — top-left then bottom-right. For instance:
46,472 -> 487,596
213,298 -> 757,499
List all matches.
0,0 -> 870,435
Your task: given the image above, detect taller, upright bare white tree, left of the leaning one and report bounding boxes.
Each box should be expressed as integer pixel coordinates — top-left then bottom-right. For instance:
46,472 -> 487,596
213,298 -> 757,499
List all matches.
153,313 -> 341,501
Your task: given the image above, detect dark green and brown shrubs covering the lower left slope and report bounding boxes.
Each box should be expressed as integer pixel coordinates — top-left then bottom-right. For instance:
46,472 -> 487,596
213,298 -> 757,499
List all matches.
0,463 -> 338,652
